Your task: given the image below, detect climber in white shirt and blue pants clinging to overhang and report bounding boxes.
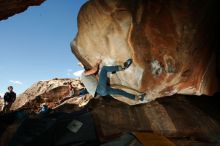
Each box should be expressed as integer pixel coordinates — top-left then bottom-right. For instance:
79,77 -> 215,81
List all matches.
81,59 -> 146,101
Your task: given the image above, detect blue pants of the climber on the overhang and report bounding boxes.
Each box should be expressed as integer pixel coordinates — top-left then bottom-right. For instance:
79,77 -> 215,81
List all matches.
96,66 -> 135,100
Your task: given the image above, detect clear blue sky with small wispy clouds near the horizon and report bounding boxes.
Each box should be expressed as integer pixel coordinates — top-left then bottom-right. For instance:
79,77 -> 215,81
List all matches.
0,0 -> 87,94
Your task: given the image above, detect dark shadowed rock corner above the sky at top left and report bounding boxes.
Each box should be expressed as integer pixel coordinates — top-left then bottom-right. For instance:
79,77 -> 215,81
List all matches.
0,0 -> 45,20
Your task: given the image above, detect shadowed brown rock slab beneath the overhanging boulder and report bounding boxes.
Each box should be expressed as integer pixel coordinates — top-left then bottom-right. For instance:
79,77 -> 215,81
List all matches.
91,94 -> 220,146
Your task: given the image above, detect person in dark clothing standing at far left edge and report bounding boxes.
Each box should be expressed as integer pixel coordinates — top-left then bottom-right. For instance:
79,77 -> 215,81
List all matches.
3,86 -> 16,112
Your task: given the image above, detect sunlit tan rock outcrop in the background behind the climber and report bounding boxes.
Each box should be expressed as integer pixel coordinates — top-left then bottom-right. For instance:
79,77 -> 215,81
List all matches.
11,78 -> 86,112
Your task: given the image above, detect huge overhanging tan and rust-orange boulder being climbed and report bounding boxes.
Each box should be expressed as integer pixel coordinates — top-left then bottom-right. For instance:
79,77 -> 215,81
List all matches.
71,0 -> 218,104
